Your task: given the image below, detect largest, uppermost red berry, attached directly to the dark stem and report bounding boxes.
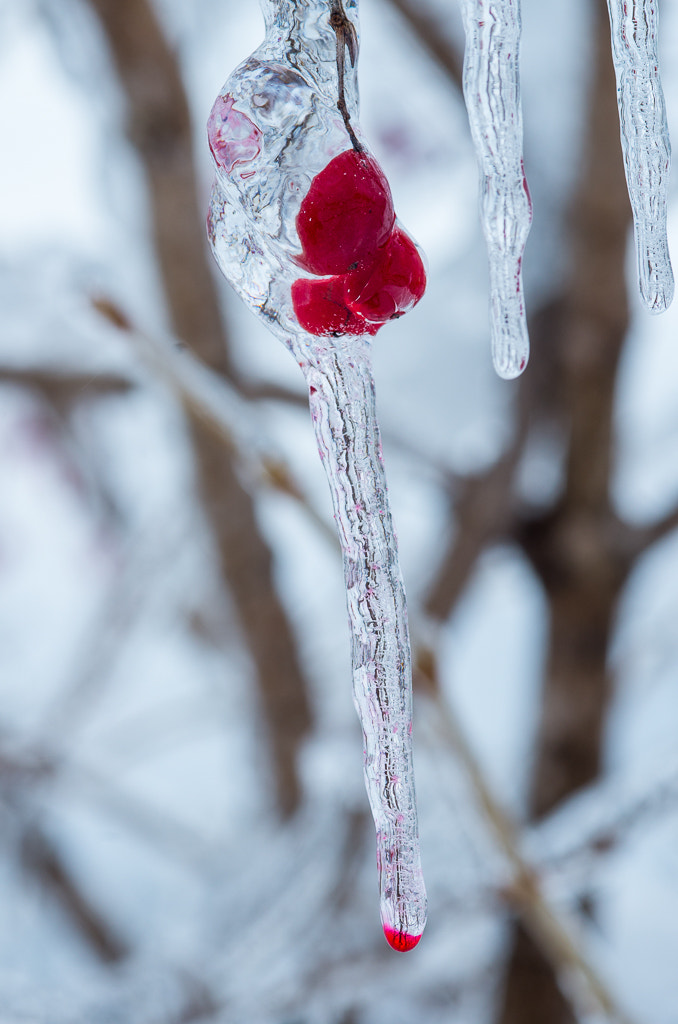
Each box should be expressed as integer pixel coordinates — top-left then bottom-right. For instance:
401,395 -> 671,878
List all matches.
297,150 -> 395,274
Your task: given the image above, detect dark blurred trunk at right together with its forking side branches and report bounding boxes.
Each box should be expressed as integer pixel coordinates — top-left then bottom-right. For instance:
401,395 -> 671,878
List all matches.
405,0 -> 678,1024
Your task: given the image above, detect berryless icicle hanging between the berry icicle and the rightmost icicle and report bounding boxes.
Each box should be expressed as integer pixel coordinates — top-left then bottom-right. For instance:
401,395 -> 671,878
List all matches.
461,0 -> 532,379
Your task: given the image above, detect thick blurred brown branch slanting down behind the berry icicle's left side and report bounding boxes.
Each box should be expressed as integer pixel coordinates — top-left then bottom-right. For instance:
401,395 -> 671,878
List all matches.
89,0 -> 311,814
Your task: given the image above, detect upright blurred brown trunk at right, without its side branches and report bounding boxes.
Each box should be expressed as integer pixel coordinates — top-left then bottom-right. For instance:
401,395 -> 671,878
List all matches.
499,0 -> 633,1024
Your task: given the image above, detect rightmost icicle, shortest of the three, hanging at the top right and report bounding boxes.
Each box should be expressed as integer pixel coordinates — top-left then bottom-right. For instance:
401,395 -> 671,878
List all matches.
607,0 -> 674,313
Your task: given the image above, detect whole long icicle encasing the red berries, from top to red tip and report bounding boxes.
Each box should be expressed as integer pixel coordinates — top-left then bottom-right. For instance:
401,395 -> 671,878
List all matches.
208,0 -> 426,950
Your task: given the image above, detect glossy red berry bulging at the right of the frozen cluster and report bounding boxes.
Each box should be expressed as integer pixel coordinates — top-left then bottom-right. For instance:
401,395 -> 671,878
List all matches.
345,227 -> 426,324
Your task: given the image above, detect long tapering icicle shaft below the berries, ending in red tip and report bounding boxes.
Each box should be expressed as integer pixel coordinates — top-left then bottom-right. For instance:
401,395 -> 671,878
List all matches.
299,338 -> 426,949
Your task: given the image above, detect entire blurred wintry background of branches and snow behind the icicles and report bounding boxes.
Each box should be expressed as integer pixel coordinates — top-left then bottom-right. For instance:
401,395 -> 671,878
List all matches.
0,0 -> 678,1024
